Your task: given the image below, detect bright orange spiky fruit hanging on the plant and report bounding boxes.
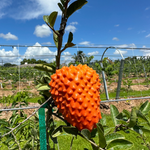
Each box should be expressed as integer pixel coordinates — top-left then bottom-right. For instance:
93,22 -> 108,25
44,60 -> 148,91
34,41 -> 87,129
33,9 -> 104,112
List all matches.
49,65 -> 101,131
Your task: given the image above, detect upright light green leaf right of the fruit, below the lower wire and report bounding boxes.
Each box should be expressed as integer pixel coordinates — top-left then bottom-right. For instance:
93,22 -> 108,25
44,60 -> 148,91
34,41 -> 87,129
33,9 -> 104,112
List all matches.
110,105 -> 119,126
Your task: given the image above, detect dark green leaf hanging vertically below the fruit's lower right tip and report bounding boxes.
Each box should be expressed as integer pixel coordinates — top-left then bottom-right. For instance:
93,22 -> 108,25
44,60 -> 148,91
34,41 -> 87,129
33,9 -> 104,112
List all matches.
96,123 -> 106,148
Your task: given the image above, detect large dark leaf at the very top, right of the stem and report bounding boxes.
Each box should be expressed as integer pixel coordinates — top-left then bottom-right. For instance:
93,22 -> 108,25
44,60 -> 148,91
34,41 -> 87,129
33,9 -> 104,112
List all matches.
67,0 -> 87,18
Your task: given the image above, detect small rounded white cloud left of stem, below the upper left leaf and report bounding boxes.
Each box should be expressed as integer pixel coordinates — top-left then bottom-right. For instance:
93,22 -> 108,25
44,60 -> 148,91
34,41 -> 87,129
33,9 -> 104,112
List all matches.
34,24 -> 52,38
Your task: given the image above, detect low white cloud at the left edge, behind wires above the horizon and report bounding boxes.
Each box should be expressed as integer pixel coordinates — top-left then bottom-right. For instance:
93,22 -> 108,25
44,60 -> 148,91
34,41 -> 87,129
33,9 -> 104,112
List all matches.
0,47 -> 22,65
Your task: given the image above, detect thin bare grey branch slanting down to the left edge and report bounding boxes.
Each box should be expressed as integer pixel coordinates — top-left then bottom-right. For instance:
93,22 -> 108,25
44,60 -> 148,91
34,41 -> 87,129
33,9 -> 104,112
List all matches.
0,97 -> 51,138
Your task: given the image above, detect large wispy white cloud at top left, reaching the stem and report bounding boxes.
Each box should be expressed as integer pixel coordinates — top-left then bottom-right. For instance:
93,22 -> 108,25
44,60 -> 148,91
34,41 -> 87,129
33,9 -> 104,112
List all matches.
7,0 -> 61,20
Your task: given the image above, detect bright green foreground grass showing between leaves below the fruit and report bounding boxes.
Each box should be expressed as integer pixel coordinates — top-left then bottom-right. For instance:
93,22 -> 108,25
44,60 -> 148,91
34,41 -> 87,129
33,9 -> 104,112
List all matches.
49,115 -> 150,150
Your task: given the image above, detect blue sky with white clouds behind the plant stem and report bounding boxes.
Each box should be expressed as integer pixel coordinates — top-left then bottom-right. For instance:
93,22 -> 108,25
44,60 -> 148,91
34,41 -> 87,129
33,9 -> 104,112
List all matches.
0,0 -> 150,63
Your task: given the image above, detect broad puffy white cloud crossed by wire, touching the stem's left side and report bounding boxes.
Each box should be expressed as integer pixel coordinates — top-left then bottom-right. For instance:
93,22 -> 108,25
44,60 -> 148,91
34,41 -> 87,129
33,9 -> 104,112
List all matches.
24,42 -> 57,61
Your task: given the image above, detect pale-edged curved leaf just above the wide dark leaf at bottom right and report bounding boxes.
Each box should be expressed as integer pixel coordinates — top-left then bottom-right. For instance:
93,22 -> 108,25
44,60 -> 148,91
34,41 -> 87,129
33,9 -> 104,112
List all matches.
105,133 -> 125,144
